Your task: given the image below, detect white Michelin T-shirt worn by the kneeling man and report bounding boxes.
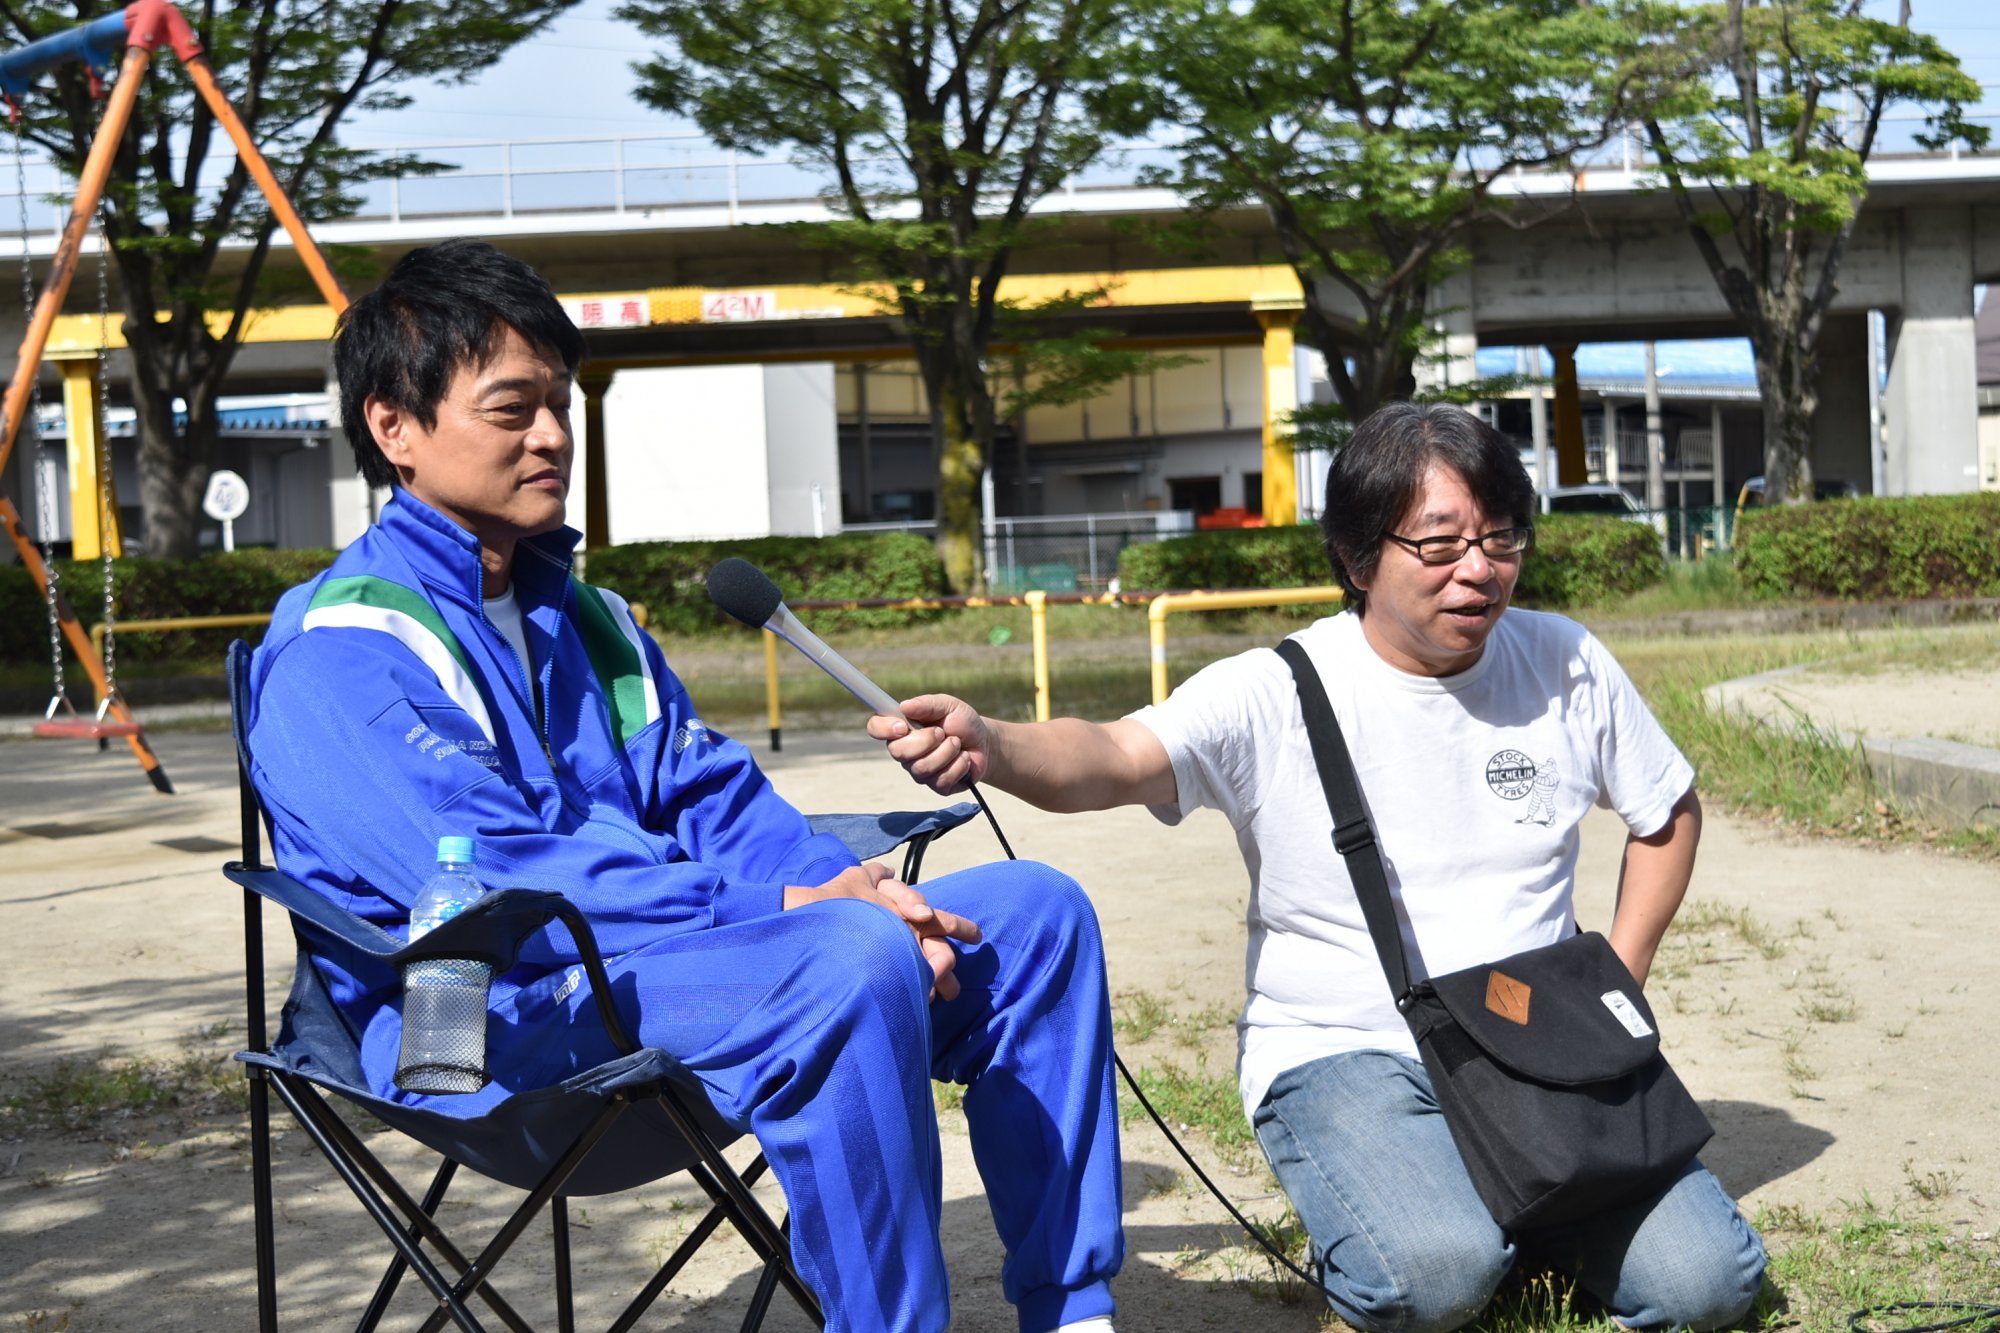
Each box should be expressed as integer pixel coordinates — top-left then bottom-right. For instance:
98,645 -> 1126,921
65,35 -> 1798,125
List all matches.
1132,610 -> 1694,1113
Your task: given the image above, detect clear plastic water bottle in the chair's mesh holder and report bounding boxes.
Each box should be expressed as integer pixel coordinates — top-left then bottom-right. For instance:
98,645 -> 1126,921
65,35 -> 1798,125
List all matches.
396,837 -> 492,1093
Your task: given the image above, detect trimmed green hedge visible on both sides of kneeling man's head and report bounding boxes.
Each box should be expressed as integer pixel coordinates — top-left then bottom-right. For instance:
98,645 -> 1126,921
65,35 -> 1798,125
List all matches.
1118,514 -> 1666,608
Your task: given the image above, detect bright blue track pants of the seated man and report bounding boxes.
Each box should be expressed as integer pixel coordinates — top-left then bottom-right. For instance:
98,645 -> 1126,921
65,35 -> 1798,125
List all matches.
572,861 -> 1124,1333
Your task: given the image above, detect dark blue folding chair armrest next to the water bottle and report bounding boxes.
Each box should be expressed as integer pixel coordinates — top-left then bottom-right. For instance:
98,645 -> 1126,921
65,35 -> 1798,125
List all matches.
222,861 -> 640,1055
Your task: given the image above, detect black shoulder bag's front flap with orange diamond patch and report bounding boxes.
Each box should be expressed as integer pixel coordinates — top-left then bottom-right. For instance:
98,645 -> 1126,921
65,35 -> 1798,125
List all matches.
1428,933 -> 1660,1085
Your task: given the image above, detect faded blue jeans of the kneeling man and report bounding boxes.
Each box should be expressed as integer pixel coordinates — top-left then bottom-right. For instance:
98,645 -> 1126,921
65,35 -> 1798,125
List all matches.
1254,1051 -> 1764,1333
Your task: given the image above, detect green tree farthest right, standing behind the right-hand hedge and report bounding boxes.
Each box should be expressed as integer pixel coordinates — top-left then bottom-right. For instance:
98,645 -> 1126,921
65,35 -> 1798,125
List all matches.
1646,0 -> 1988,502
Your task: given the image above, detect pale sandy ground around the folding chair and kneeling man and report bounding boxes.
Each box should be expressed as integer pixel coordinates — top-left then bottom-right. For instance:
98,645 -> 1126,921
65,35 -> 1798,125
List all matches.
0,668 -> 2000,1333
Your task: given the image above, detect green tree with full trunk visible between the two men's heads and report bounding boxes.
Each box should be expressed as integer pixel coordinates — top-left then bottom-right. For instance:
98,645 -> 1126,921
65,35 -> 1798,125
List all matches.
620,0 -> 1138,590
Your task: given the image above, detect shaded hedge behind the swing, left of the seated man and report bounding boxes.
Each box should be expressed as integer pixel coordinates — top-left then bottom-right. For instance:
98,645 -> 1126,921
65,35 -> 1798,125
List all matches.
0,550 -> 334,662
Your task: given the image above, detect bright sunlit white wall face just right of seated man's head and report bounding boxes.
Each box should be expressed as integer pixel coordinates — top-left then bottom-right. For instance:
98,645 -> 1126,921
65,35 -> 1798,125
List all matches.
604,366 -> 764,544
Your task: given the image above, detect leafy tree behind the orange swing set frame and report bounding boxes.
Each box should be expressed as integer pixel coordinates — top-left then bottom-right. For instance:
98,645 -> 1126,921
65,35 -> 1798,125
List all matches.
0,0 -> 574,556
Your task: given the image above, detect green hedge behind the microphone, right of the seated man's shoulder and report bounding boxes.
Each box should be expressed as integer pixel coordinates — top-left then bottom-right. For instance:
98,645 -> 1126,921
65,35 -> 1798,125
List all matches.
590,532 -> 948,634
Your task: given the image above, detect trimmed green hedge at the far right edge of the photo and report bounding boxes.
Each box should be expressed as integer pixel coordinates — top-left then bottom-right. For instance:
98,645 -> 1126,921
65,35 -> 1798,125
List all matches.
1736,490 -> 2000,600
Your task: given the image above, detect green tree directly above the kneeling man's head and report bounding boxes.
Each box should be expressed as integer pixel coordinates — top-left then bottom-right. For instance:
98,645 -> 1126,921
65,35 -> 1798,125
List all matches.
1132,0 -> 1628,434
